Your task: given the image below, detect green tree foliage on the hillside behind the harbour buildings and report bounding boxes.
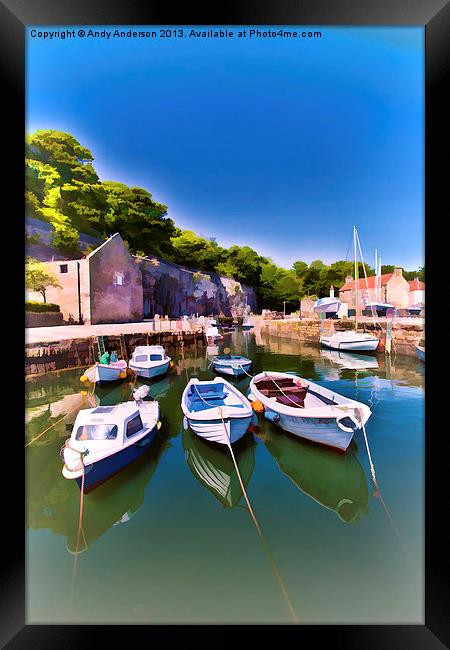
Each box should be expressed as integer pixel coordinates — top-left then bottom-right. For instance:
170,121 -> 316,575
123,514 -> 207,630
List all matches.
25,130 -> 425,310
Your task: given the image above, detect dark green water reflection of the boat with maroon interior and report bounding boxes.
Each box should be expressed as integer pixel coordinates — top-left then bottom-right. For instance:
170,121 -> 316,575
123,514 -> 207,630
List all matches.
261,428 -> 369,523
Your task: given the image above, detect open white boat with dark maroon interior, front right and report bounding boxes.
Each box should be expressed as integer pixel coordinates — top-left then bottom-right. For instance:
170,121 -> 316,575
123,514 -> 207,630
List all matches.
249,371 -> 371,451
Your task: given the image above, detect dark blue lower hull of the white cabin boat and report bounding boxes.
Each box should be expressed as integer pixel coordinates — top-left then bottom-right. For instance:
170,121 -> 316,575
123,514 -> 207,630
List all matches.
75,424 -> 158,494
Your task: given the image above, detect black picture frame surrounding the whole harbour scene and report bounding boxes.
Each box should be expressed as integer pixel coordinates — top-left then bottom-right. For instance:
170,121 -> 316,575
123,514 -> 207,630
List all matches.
5,0 -> 450,650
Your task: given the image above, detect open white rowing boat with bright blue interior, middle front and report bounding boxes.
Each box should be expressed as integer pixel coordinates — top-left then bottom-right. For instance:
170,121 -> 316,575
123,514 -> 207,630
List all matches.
181,377 -> 253,445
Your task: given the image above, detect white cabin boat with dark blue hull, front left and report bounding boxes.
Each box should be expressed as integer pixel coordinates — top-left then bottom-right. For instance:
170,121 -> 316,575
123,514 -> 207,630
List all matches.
61,386 -> 161,493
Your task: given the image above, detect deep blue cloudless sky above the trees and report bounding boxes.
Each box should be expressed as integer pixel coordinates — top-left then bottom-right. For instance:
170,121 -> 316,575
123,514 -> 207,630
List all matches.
26,25 -> 424,270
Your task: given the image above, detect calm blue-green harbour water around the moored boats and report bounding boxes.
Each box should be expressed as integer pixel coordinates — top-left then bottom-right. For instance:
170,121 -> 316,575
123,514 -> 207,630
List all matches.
26,332 -> 424,623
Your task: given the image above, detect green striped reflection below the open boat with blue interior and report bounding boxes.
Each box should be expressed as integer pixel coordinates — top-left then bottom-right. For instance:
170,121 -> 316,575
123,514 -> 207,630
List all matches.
182,429 -> 255,508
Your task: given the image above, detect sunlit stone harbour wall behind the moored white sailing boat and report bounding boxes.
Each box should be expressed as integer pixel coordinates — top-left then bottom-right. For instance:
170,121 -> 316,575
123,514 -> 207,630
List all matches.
258,319 -> 424,356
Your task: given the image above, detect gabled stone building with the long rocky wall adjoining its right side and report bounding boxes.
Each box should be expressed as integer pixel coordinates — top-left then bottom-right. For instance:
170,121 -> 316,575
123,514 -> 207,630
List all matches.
26,233 -> 256,325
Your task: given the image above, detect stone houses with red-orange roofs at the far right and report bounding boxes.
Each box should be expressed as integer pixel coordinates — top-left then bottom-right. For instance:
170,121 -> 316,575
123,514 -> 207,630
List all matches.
339,268 -> 425,310
